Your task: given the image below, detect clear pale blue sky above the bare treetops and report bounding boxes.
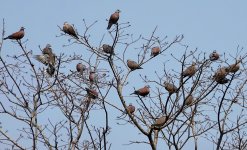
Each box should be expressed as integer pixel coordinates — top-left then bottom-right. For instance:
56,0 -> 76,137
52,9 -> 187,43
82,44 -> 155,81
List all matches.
0,0 -> 247,150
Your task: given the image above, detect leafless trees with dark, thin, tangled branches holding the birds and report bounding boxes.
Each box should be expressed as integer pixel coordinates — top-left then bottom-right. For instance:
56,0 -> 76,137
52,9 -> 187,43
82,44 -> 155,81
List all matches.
0,14 -> 247,150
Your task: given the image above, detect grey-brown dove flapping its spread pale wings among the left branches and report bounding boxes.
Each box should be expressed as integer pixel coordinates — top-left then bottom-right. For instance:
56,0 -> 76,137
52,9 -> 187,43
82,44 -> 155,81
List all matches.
34,44 -> 56,67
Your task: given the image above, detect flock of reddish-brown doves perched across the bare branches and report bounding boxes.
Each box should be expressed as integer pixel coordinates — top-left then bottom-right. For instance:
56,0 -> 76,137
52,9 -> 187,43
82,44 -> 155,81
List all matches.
1,10 -> 241,125
